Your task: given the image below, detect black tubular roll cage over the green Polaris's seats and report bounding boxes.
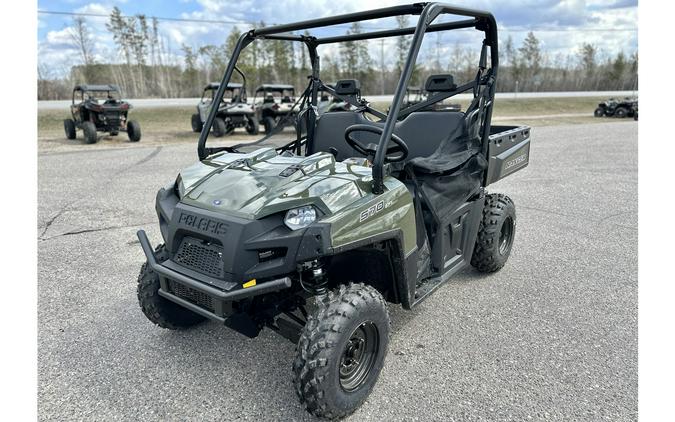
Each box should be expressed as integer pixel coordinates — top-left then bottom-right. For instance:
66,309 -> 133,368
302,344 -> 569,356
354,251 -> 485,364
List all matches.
197,3 -> 499,194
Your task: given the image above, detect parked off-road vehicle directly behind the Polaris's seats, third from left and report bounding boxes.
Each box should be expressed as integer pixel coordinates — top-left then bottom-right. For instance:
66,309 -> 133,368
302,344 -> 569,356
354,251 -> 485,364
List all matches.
253,84 -> 295,134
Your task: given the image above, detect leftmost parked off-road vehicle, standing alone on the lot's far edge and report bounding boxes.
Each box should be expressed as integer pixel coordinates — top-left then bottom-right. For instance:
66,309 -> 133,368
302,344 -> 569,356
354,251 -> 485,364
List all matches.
63,85 -> 141,144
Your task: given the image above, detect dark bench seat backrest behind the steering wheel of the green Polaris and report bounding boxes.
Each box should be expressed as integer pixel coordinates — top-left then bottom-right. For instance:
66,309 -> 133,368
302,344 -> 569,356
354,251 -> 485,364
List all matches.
308,111 -> 467,160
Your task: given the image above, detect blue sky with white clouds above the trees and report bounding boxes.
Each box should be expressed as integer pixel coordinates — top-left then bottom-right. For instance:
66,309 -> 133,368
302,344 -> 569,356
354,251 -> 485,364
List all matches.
37,0 -> 638,76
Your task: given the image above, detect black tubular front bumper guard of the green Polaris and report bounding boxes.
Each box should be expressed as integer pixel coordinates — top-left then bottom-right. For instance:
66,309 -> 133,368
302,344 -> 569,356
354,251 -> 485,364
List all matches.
136,230 -> 291,322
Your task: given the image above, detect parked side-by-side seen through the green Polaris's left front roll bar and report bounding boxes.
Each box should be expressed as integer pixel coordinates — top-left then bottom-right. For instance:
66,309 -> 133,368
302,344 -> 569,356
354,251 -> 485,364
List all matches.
191,82 -> 258,137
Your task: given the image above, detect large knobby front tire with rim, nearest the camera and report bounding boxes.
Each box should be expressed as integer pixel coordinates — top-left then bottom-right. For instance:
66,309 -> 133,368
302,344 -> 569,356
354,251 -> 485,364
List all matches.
293,283 -> 389,419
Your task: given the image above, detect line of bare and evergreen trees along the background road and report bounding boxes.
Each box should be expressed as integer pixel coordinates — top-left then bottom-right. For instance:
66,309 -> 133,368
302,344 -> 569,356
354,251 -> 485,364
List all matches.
38,7 -> 638,100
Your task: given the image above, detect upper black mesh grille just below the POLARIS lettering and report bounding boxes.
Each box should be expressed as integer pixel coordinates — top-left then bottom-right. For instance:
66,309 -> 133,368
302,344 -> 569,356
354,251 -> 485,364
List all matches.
173,237 -> 225,278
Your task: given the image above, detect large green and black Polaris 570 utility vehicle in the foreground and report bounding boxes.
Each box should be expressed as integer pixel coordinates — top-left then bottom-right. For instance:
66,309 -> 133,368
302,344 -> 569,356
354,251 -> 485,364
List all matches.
138,3 -> 530,418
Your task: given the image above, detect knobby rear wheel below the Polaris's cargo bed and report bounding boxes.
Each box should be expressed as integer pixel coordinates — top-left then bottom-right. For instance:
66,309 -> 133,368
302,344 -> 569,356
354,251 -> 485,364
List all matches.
471,194 -> 516,273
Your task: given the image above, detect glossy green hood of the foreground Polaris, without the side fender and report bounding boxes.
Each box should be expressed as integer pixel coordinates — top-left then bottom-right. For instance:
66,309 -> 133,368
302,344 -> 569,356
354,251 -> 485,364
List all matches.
179,148 -> 372,219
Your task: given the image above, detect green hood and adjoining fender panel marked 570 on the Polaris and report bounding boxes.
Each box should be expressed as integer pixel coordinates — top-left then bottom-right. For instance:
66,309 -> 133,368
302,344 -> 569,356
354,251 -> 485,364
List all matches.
178,148 -> 416,255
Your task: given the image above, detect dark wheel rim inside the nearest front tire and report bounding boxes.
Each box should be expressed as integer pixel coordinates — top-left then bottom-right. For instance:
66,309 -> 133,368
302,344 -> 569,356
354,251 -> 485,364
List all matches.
340,321 -> 380,392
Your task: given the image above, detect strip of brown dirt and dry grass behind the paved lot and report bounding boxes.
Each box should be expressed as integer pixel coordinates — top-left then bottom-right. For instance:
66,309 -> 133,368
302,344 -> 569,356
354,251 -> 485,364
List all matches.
38,97 -> 618,152
